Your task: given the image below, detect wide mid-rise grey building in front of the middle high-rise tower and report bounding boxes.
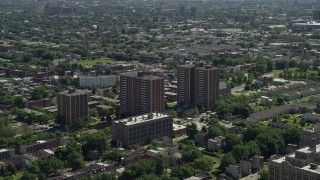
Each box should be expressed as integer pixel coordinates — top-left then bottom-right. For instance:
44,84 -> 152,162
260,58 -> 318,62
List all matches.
111,113 -> 173,147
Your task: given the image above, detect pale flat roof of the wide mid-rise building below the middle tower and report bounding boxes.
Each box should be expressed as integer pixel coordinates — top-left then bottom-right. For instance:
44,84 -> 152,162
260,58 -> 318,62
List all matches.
114,113 -> 170,126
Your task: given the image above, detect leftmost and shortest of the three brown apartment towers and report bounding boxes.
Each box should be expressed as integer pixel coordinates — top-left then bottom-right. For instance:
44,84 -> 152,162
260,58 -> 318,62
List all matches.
57,89 -> 89,126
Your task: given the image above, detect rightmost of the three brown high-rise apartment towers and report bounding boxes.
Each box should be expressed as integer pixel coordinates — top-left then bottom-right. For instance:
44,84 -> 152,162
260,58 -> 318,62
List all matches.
177,63 -> 219,109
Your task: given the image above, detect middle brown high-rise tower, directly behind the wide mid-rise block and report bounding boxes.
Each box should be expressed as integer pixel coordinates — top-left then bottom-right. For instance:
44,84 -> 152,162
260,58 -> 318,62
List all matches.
120,73 -> 165,117
